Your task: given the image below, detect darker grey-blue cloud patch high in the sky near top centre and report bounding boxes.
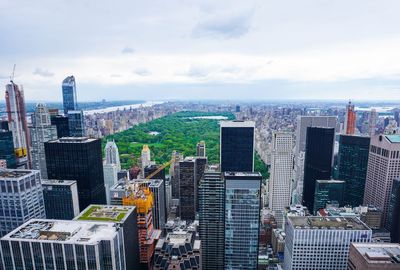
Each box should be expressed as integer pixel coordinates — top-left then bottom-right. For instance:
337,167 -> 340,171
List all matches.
192,11 -> 253,39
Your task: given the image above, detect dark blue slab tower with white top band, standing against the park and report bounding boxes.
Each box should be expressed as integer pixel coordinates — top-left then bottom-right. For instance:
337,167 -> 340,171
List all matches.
220,121 -> 255,172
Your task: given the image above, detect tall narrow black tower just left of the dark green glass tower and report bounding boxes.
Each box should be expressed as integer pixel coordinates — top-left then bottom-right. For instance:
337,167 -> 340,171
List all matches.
303,127 -> 335,212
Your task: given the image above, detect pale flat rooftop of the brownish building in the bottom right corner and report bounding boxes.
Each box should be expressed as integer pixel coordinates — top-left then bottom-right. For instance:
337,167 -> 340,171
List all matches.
353,243 -> 400,265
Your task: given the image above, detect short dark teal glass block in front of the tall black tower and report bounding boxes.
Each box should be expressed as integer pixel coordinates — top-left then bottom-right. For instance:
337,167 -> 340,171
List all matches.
314,180 -> 345,214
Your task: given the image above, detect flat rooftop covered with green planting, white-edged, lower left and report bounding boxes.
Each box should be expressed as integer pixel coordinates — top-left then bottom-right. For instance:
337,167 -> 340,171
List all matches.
74,205 -> 135,222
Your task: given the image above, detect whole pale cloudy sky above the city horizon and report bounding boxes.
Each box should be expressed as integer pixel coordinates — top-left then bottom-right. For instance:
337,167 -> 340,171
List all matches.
0,0 -> 400,101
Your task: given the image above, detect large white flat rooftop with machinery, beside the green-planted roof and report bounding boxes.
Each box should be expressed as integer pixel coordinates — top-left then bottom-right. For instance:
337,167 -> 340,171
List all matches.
2,219 -> 118,244
